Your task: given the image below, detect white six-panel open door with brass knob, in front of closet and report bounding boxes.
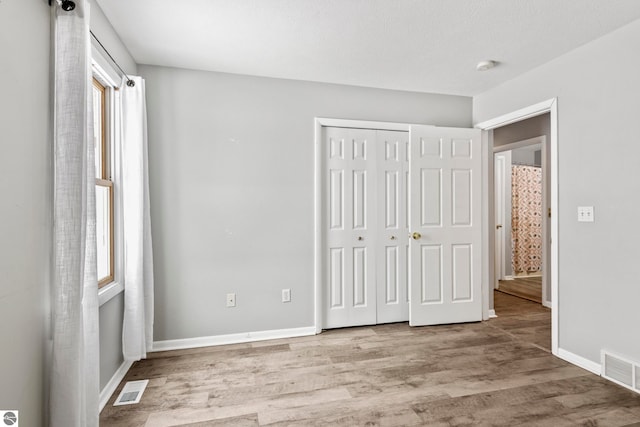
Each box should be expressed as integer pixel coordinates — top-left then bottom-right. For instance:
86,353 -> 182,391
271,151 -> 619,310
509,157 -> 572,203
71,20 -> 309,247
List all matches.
409,126 -> 482,326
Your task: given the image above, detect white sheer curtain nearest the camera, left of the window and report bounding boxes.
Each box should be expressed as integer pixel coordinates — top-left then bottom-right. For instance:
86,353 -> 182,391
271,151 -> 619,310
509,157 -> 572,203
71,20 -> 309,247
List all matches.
49,0 -> 100,427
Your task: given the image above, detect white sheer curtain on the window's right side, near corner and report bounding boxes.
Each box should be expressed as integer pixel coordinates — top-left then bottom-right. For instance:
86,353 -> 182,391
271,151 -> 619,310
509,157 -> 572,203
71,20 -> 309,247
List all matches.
120,76 -> 153,360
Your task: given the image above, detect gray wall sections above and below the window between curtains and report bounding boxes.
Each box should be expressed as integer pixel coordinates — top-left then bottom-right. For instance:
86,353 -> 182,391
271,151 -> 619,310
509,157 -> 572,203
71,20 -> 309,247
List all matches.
91,1 -> 137,390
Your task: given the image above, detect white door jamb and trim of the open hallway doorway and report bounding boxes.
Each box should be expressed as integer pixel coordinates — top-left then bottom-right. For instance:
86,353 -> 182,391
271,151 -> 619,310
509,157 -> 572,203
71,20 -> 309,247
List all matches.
475,98 -> 560,356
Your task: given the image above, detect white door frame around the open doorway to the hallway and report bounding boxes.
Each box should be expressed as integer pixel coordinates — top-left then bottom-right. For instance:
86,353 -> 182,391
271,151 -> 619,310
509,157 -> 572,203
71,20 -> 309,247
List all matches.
475,98 -> 560,356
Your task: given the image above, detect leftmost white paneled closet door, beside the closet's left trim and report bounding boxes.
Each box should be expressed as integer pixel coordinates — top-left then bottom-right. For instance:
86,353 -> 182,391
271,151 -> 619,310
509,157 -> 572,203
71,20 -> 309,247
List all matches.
323,127 -> 377,328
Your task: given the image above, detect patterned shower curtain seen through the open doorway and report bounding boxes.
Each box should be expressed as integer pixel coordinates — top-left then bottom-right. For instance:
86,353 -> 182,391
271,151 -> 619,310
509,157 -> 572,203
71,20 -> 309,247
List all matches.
511,165 -> 542,274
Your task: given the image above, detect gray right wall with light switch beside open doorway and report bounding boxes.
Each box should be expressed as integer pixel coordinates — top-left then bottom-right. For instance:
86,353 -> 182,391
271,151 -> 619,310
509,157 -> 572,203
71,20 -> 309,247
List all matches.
473,17 -> 640,363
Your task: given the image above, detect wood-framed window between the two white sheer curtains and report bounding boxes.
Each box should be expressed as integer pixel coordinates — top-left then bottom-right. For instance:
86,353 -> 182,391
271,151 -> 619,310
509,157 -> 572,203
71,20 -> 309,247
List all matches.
93,79 -> 114,287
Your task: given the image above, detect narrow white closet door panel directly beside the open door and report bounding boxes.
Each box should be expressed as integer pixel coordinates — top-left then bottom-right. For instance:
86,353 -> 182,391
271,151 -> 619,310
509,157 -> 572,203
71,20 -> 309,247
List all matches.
376,131 -> 409,323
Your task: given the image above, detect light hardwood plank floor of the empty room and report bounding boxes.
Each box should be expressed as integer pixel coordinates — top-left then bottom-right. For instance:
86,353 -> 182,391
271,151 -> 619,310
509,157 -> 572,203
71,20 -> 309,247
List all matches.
100,293 -> 640,427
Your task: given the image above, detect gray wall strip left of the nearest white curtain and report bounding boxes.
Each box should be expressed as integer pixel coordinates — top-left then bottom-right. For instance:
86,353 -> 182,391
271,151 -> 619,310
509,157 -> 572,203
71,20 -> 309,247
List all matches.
0,0 -> 51,426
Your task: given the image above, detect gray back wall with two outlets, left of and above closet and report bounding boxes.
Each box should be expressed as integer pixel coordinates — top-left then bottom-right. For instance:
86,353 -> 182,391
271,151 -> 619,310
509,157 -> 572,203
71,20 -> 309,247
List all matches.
139,65 -> 471,341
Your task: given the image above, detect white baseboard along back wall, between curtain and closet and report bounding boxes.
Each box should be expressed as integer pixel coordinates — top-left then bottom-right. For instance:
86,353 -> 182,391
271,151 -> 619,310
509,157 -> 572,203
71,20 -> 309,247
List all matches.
153,326 -> 316,351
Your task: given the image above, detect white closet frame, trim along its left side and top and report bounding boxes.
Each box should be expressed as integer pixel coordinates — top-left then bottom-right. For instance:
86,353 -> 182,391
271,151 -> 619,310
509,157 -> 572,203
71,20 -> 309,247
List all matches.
313,117 -> 411,334
